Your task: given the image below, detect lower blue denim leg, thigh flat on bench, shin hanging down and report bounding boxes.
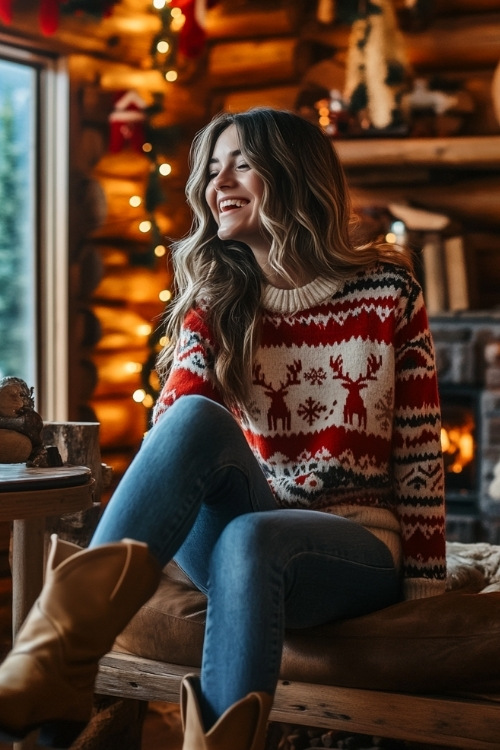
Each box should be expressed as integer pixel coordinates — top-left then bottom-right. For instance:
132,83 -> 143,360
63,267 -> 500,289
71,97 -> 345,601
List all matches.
201,509 -> 400,728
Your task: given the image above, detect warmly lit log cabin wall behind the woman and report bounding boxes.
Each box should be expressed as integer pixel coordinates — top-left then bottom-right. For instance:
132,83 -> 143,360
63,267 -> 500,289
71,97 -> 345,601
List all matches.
0,0 -> 500,494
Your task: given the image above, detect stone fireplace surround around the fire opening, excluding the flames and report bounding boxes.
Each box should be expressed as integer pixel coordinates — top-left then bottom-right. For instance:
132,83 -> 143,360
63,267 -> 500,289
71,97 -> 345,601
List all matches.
430,310 -> 500,544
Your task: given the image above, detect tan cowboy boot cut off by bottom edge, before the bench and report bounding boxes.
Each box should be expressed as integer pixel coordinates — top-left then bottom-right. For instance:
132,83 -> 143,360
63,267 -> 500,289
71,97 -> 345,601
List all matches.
181,675 -> 273,750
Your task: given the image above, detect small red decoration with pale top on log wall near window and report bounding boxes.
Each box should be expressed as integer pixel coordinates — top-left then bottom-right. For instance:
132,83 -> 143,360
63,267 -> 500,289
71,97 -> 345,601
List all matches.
109,91 -> 146,154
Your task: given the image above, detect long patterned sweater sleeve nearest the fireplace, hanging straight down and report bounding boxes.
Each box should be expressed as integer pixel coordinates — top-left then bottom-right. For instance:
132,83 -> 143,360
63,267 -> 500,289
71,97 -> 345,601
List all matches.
393,280 -> 446,599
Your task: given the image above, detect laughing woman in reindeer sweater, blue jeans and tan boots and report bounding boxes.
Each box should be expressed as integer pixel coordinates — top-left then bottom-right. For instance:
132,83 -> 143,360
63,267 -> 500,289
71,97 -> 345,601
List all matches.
0,109 -> 445,750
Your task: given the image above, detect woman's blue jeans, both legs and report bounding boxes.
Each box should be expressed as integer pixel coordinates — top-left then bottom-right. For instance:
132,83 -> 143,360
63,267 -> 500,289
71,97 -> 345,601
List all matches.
91,396 -> 400,729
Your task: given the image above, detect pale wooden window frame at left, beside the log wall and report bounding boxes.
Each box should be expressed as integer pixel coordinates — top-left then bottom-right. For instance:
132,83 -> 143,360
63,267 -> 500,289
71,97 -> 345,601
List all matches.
0,34 -> 69,421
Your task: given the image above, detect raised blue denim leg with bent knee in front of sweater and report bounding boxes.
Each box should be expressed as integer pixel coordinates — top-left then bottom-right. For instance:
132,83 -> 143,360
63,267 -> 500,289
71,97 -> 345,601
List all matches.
90,396 -> 276,572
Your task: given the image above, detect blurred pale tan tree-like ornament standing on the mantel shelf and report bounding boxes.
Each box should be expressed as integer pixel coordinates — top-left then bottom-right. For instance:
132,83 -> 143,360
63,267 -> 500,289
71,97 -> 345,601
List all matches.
344,0 -> 408,129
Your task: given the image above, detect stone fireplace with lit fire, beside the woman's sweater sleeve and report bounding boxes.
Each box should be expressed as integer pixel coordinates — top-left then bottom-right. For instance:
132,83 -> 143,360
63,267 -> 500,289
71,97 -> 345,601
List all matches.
430,312 -> 500,544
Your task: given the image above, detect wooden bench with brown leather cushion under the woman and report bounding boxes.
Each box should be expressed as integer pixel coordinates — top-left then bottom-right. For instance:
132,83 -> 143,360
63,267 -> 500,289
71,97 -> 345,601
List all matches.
88,548 -> 500,750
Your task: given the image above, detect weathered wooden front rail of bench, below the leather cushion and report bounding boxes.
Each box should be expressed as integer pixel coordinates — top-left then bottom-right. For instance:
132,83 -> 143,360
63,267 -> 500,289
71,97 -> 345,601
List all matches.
96,652 -> 500,750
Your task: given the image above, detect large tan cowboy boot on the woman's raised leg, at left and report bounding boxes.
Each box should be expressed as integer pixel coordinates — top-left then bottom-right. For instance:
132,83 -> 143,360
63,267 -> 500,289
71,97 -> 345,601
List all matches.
0,534 -> 160,748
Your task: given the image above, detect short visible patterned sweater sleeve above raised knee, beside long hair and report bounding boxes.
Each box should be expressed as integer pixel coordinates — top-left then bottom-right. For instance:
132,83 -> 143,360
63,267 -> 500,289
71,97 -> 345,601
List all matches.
153,310 -> 223,423
